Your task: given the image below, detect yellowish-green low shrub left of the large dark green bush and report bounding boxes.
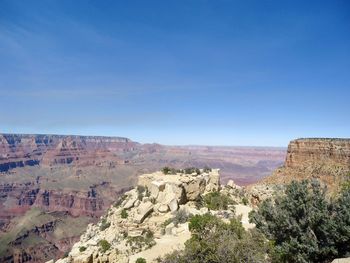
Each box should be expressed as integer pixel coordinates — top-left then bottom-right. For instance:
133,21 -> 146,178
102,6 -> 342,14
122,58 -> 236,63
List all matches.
160,214 -> 268,263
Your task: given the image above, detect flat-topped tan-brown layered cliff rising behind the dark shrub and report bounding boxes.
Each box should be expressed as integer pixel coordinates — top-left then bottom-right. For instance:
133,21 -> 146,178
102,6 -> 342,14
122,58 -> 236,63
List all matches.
263,138 -> 350,192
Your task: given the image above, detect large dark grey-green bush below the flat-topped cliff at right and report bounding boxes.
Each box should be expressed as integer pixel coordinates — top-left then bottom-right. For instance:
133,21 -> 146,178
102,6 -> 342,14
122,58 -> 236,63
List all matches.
250,180 -> 350,263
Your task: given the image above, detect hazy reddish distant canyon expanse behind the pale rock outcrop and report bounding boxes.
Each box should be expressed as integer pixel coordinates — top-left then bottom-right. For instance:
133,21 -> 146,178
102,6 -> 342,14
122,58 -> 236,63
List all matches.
0,134 -> 286,262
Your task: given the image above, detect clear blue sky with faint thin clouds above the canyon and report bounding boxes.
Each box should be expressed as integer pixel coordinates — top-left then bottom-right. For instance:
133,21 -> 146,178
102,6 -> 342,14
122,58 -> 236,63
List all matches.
0,0 -> 350,146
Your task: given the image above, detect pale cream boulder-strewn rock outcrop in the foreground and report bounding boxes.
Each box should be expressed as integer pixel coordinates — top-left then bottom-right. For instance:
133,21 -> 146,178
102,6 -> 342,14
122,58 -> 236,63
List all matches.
50,170 -> 254,263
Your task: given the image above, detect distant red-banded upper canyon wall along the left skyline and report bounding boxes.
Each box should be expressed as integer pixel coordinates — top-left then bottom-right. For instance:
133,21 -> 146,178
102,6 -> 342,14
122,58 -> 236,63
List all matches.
0,134 -> 137,172
